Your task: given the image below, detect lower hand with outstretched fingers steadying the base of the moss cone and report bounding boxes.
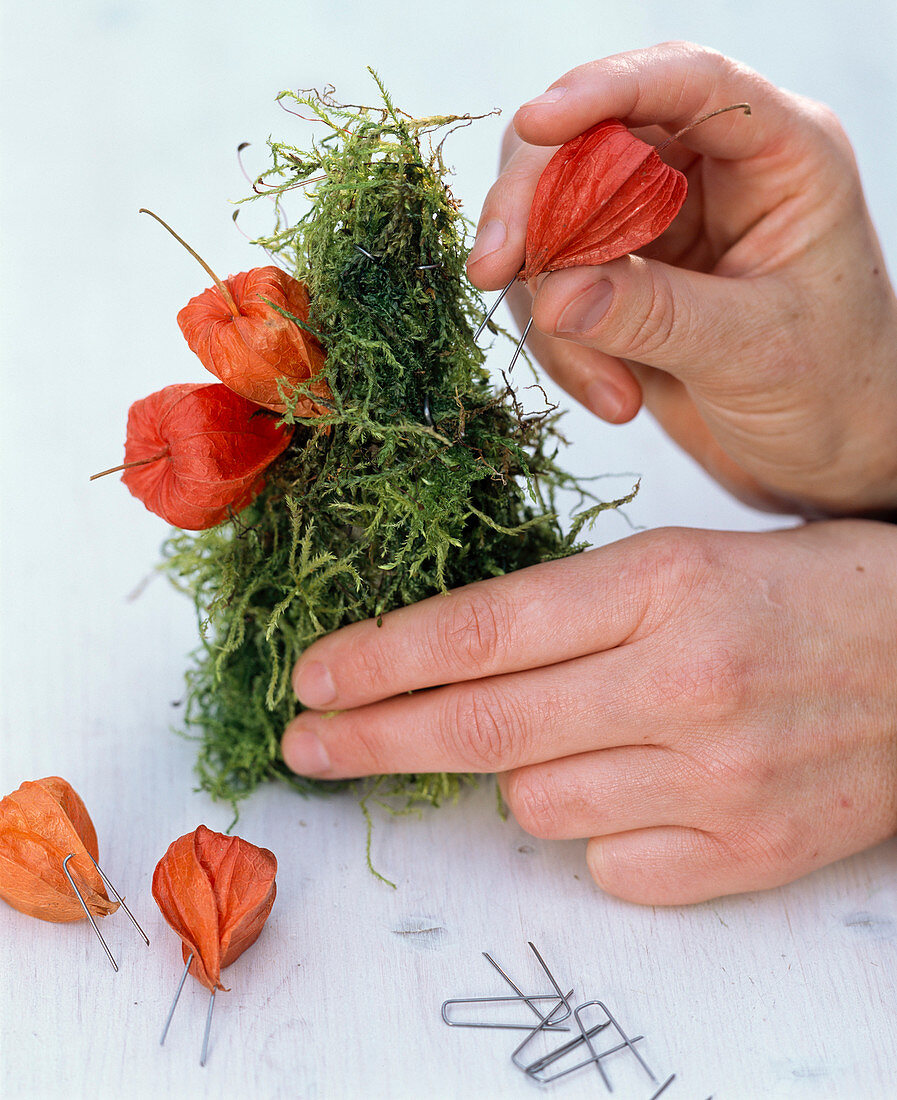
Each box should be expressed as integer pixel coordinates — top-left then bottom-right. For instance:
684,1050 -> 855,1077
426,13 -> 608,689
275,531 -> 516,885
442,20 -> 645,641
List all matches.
283,520 -> 897,904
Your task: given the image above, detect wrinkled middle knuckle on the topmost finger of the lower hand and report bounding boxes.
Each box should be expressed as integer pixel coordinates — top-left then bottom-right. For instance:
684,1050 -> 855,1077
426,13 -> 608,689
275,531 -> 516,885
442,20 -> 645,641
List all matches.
431,587 -> 512,673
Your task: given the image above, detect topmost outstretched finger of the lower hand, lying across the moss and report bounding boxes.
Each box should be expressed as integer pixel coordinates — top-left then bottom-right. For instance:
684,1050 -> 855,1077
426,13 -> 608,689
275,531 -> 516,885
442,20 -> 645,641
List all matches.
293,536 -> 648,710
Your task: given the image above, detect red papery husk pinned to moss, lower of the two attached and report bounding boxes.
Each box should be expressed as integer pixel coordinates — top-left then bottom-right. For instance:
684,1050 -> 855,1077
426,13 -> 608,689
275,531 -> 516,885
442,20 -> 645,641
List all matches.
121,383 -> 293,530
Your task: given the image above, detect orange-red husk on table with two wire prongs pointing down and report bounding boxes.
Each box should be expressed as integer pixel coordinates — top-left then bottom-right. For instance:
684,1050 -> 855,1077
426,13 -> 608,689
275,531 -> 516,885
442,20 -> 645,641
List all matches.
153,825 -> 277,990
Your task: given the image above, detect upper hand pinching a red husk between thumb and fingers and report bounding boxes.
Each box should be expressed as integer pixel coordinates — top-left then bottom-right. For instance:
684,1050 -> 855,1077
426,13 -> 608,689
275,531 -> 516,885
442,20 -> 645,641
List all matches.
468,43 -> 897,516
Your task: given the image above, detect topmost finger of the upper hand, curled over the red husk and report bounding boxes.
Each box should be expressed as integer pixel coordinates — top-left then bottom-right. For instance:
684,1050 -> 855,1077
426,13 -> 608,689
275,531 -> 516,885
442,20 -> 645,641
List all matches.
514,42 -> 795,160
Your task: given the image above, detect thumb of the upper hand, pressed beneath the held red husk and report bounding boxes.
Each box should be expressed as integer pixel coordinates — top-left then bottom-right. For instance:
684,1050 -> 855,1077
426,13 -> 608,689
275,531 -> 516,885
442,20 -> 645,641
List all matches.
533,256 -> 794,388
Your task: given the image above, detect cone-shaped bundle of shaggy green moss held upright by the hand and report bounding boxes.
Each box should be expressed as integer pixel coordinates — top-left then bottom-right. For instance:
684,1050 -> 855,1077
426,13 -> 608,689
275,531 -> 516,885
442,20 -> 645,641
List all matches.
166,75 -> 633,809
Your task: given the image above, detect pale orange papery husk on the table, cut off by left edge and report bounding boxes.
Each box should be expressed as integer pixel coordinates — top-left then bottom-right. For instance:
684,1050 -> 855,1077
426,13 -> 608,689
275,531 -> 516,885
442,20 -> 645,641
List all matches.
0,776 -> 119,923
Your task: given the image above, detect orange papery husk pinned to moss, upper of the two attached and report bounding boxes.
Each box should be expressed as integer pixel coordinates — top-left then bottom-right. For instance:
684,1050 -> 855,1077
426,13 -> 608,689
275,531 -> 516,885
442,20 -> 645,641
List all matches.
177,267 -> 330,417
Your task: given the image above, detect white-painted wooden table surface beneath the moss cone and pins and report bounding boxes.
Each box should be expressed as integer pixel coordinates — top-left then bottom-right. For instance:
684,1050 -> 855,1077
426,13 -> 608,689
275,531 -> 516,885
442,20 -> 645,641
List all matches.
0,0 -> 897,1100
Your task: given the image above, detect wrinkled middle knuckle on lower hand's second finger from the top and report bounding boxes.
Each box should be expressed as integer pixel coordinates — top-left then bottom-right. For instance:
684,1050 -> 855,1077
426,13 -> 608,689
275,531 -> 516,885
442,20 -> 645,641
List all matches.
446,683 -> 516,772
